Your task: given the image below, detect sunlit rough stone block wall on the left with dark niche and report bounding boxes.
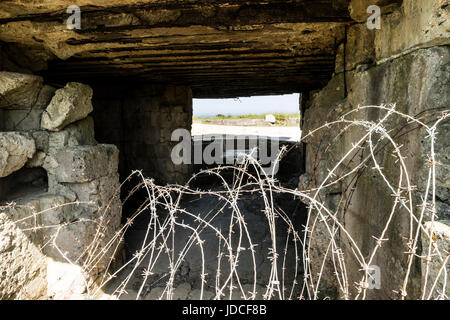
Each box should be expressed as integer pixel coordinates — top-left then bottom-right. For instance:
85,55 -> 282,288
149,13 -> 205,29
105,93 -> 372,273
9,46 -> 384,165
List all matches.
0,72 -> 122,299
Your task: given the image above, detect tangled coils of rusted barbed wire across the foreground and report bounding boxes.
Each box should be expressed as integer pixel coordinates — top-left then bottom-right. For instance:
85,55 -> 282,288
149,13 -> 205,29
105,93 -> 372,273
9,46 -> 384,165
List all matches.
0,105 -> 450,299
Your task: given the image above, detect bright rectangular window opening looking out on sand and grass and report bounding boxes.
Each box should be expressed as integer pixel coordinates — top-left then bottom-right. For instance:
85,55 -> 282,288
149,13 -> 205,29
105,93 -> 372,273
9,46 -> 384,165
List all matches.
191,93 -> 301,141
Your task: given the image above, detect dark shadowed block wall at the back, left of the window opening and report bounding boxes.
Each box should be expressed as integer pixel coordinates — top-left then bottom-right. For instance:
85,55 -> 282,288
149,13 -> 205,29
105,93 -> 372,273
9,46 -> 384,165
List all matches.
94,84 -> 192,183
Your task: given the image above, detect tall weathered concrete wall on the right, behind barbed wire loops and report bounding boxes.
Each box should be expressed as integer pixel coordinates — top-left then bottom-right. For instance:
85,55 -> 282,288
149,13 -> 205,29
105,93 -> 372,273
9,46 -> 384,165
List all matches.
300,0 -> 450,298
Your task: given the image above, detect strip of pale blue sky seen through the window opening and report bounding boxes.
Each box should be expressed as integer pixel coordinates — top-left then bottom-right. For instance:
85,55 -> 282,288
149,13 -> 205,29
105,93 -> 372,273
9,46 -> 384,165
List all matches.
193,93 -> 299,117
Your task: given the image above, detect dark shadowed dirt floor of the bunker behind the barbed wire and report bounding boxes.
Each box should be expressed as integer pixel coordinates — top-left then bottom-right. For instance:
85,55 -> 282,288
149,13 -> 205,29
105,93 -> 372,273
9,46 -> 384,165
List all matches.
105,188 -> 304,300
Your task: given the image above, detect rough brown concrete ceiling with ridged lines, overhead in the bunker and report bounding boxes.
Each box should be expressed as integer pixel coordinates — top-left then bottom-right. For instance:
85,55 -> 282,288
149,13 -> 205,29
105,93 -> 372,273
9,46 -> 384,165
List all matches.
0,0 -> 350,97
